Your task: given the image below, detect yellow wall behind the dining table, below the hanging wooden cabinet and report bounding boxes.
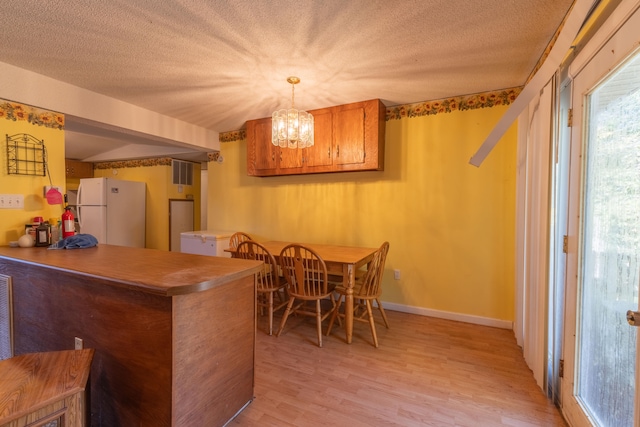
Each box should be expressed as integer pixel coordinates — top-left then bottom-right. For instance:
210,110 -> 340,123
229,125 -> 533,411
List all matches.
208,106 -> 516,321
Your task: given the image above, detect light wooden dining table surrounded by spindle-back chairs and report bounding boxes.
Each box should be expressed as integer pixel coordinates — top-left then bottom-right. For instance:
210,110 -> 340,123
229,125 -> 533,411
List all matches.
226,240 -> 378,344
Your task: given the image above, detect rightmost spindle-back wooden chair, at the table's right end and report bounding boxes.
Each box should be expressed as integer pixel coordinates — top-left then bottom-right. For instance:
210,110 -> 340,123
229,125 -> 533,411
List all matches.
327,242 -> 389,348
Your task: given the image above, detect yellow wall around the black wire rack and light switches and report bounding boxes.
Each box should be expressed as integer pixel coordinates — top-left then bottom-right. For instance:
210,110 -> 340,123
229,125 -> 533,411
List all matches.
0,100 -> 65,245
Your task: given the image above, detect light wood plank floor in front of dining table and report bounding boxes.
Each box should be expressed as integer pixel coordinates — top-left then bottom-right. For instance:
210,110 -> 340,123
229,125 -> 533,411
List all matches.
231,311 -> 566,427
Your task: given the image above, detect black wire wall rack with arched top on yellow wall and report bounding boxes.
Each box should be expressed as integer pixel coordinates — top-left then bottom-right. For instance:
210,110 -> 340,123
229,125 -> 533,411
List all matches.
7,133 -> 47,176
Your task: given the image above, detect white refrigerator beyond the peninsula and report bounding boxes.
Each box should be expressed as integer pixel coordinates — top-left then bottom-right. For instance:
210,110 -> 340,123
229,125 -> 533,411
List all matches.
76,178 -> 146,248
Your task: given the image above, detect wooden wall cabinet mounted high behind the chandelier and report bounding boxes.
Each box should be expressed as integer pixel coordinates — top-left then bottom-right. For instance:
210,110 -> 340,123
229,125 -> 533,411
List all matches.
247,99 -> 386,176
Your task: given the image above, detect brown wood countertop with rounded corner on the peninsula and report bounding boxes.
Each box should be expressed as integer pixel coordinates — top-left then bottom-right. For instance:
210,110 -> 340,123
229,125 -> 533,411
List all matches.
0,244 -> 261,296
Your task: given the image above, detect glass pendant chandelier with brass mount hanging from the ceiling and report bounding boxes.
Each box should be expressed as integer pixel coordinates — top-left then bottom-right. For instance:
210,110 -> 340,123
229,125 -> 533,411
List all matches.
271,76 -> 313,148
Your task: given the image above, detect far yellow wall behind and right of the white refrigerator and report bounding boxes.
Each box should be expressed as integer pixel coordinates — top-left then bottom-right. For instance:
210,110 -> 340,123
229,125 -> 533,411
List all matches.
93,161 -> 201,250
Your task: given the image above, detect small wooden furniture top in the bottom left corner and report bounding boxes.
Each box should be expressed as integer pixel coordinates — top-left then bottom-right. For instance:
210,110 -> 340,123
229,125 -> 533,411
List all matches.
0,349 -> 94,427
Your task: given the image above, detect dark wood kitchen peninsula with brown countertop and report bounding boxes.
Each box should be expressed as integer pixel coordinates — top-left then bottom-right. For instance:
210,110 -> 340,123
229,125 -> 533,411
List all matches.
0,245 -> 260,427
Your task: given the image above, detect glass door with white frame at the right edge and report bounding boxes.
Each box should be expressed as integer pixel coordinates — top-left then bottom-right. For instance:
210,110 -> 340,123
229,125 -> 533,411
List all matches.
562,45 -> 640,427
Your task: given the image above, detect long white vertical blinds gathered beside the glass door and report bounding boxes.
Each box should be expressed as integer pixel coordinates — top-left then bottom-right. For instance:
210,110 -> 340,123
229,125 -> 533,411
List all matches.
514,82 -> 554,388
